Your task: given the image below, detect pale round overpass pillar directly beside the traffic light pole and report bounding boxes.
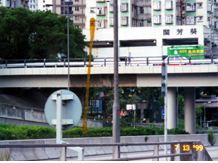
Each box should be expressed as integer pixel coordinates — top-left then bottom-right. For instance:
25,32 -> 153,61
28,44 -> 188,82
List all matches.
167,87 -> 177,129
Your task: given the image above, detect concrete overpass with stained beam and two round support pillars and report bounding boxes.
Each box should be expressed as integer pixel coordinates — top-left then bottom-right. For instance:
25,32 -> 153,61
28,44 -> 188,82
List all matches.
0,58 -> 218,133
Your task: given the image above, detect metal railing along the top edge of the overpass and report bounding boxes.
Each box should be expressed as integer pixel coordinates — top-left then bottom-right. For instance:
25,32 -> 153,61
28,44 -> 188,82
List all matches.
0,55 -> 218,69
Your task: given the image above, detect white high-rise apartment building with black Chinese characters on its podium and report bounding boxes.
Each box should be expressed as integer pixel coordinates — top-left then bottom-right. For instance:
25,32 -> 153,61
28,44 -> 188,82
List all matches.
83,0 -> 218,57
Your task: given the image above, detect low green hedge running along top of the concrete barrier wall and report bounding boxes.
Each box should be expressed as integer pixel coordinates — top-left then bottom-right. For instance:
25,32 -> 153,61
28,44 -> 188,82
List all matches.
0,123 -> 188,140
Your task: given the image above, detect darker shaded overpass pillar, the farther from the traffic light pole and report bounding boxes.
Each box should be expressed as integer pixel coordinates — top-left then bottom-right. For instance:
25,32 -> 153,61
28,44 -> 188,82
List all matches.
184,87 -> 196,134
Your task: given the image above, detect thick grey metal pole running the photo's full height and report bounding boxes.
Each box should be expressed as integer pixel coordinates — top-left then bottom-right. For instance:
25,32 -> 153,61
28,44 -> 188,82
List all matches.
113,0 -> 120,159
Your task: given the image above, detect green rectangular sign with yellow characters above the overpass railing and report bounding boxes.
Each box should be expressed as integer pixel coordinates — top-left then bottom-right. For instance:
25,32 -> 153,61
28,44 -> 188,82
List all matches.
167,46 -> 204,58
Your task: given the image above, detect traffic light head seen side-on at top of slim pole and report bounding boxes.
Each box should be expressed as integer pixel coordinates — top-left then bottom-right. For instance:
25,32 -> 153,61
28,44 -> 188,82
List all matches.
161,61 -> 167,96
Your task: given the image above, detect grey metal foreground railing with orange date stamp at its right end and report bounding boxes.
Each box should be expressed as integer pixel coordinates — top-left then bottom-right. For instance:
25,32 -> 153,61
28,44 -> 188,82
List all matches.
0,141 -> 212,161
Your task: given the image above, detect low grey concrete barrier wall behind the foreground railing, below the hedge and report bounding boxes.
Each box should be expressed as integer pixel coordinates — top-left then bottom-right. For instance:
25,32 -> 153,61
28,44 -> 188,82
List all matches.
0,134 -> 215,161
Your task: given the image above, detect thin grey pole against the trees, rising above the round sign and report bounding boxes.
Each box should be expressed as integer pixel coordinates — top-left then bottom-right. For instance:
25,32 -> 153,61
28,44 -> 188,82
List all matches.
67,4 -> 70,90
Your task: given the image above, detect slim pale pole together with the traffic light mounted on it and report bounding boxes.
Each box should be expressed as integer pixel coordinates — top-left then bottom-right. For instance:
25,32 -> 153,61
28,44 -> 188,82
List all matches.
161,60 -> 167,161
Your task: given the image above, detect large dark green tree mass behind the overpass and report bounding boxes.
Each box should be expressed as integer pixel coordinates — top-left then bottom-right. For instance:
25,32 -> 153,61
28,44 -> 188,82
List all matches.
0,7 -> 87,59
